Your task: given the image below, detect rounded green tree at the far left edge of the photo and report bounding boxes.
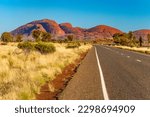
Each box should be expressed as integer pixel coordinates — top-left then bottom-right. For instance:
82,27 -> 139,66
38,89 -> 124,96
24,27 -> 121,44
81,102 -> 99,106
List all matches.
1,32 -> 13,42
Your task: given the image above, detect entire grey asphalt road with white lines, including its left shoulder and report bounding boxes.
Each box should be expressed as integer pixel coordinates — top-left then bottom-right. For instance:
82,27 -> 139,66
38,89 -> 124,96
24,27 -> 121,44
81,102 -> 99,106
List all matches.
59,45 -> 150,100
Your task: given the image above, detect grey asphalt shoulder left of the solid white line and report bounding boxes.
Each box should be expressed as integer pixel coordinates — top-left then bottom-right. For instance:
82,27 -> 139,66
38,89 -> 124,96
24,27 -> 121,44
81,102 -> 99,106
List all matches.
59,47 -> 103,100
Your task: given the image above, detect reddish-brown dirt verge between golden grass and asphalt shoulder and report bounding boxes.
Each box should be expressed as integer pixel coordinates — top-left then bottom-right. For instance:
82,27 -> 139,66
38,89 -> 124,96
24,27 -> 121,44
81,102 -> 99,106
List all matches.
36,52 -> 87,100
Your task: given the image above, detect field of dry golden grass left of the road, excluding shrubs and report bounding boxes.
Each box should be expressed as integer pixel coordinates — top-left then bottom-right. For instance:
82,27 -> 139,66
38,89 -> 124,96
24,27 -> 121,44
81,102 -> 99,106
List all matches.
0,43 -> 91,99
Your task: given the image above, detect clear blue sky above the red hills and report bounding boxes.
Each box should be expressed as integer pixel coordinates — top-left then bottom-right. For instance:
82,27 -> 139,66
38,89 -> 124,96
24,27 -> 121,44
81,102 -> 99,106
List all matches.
0,0 -> 150,33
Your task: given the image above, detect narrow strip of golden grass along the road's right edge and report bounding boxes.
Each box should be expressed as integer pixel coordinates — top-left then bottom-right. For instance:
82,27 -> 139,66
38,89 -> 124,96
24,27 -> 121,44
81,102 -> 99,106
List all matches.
115,46 -> 150,54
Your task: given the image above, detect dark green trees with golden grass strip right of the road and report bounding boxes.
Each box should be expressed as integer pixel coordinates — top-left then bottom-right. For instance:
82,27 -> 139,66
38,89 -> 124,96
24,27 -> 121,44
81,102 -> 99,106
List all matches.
113,32 -> 150,54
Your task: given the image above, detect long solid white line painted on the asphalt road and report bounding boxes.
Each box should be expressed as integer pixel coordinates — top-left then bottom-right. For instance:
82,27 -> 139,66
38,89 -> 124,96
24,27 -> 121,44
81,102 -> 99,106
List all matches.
95,47 -> 109,100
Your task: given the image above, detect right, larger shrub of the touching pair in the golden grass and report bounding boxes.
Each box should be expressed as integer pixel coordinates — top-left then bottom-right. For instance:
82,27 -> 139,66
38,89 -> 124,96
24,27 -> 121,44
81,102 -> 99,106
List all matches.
35,42 -> 56,53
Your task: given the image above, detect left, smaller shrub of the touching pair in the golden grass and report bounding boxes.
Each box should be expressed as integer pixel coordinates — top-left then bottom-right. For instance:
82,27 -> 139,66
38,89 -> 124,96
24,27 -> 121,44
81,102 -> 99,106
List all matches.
18,42 -> 35,50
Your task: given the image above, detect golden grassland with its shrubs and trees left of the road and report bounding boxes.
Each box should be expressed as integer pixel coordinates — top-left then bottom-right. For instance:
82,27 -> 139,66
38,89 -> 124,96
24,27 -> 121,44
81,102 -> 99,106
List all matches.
0,30 -> 91,99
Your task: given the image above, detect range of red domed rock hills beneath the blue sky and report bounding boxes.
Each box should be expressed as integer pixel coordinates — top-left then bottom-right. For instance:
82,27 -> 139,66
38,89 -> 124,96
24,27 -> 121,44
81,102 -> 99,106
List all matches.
11,19 -> 150,40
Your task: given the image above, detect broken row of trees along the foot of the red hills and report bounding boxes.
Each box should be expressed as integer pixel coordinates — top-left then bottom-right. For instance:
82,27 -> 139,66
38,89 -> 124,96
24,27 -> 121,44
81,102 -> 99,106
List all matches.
1,30 -> 150,47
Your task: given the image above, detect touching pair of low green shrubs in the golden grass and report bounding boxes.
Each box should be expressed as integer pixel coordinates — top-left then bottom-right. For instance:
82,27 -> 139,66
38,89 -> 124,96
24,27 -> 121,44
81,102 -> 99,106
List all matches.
18,42 -> 56,53
